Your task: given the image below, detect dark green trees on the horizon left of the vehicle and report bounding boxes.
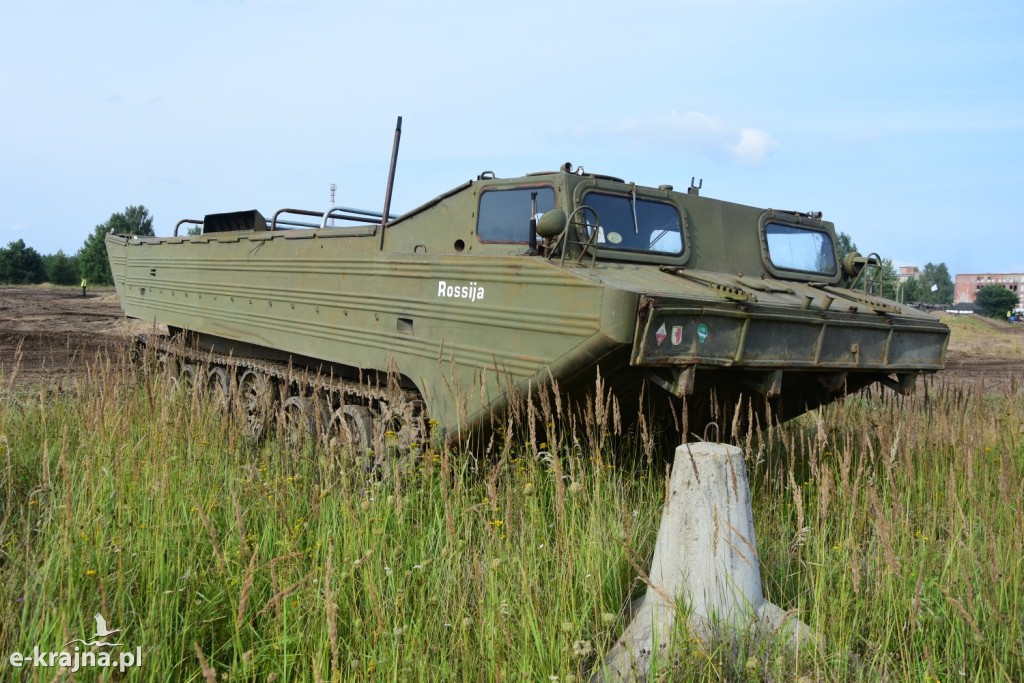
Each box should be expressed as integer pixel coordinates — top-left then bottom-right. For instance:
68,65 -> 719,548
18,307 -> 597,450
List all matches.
0,205 -> 154,285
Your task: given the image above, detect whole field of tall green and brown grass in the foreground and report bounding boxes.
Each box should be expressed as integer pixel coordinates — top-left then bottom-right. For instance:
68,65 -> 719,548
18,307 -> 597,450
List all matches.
0,350 -> 1024,682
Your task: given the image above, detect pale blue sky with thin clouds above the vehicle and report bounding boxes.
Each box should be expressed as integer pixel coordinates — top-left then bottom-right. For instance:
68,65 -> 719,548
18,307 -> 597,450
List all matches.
0,0 -> 1024,273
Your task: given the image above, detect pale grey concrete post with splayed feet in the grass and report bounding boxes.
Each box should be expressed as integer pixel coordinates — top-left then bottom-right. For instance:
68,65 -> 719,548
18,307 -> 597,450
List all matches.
591,443 -> 814,681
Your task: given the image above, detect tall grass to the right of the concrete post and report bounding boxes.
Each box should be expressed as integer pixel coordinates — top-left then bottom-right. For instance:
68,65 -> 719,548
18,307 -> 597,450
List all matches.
755,384 -> 1024,681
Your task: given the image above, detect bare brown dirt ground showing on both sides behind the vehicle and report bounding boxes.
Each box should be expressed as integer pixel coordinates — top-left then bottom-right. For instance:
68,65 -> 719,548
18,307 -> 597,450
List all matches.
0,286 -> 1024,388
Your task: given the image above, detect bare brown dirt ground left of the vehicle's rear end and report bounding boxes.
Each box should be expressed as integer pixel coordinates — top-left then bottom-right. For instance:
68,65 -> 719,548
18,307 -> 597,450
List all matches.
0,286 -> 163,389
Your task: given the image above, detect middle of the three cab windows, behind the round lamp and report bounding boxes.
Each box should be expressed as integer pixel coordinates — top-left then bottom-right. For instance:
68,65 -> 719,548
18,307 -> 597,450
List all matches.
581,193 -> 684,256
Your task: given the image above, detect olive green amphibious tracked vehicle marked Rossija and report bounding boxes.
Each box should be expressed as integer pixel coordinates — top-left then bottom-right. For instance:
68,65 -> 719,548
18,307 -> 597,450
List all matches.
106,119 -> 948,443
